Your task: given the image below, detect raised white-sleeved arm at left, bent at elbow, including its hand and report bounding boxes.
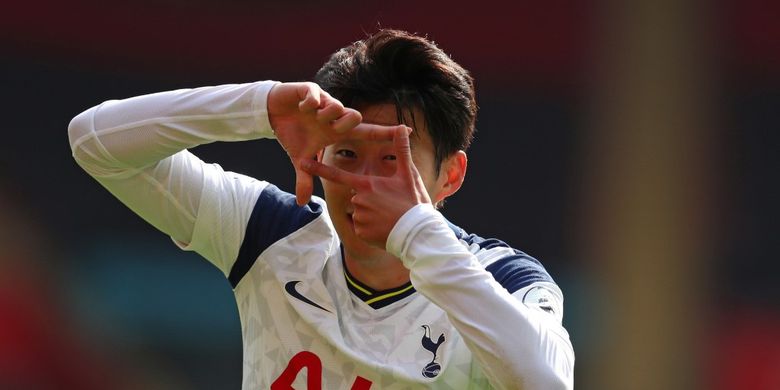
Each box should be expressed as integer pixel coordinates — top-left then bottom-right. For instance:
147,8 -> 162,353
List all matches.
68,82 -> 368,273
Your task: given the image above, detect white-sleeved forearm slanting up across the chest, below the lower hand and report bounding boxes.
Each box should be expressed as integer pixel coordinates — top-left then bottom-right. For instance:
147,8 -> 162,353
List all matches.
388,206 -> 574,389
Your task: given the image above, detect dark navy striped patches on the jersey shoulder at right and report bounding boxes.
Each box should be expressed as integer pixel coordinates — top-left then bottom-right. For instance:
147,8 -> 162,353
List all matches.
449,223 -> 555,294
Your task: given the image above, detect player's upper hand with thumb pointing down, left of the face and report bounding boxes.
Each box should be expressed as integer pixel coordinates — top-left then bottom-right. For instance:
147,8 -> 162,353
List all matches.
268,83 -> 362,206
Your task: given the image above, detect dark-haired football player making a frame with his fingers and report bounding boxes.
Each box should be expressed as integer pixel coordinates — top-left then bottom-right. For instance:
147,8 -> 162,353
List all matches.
69,30 -> 574,389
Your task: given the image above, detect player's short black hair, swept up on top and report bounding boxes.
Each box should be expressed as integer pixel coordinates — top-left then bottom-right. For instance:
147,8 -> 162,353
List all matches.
315,29 -> 477,174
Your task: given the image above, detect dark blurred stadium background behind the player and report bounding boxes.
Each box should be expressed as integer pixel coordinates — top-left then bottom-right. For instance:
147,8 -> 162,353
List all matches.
0,0 -> 780,390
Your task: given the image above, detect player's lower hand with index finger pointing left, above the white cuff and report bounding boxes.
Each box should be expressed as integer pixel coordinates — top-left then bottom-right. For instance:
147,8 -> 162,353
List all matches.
301,126 -> 431,249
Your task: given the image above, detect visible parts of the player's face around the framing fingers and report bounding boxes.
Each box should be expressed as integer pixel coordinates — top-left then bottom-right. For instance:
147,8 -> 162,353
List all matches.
321,104 -> 447,259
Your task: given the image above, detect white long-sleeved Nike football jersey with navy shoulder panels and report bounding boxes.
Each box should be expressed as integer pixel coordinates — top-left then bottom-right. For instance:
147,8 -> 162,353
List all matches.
70,82 -> 574,389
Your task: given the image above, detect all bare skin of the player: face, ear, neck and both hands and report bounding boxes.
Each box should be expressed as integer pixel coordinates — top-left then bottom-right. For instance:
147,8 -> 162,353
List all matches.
268,83 -> 467,290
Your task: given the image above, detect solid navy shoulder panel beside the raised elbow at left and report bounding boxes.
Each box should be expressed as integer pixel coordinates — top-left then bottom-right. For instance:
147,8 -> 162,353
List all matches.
228,184 -> 322,288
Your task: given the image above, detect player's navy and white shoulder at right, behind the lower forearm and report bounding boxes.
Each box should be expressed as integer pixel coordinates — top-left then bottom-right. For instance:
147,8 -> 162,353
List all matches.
449,223 -> 555,294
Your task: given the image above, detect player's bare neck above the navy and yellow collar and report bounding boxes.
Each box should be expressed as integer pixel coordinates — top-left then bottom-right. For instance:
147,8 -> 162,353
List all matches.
344,248 -> 409,291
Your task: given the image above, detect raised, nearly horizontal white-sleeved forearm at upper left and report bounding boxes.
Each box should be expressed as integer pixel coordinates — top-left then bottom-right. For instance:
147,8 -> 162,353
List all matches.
68,82 -> 273,178
